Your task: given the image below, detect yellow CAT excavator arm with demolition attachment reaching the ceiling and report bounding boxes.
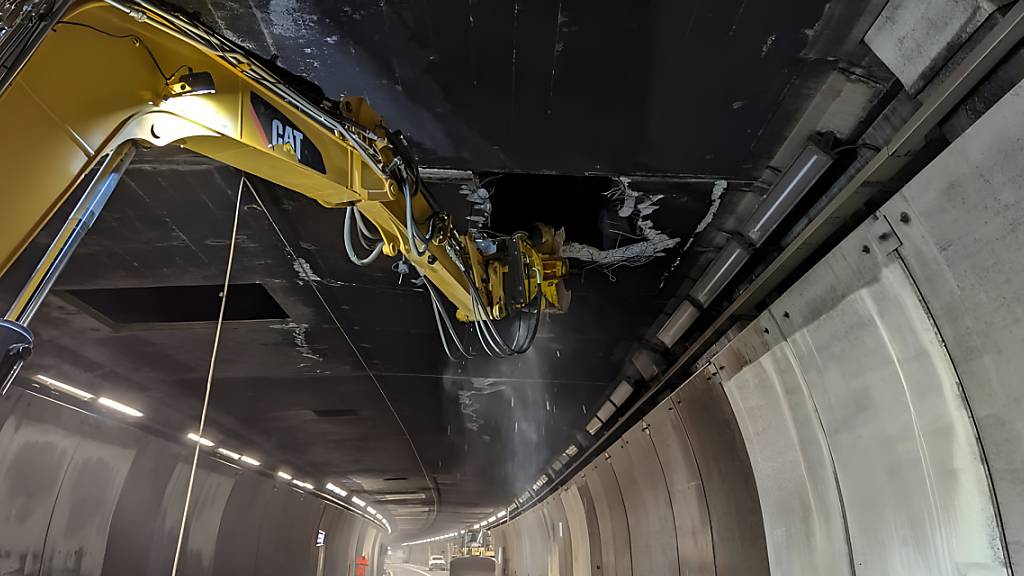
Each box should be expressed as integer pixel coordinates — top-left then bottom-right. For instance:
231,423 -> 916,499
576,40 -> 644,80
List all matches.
0,1 -> 567,332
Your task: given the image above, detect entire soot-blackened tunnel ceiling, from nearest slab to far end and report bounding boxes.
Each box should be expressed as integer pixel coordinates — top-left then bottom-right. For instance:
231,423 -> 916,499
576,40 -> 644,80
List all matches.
0,0 -> 888,538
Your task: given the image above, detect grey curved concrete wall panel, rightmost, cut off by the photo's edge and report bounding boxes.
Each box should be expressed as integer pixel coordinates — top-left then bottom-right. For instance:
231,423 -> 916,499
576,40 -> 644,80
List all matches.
882,77 -> 1024,574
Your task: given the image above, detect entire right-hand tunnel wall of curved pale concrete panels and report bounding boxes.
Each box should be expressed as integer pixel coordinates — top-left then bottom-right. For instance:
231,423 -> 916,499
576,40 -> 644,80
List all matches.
493,62 -> 1024,576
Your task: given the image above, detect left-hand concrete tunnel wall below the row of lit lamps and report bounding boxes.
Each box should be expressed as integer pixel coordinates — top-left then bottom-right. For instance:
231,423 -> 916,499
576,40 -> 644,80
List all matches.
0,388 -> 383,576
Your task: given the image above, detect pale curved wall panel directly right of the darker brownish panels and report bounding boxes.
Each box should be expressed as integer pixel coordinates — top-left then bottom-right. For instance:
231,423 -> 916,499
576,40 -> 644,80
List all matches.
715,316 -> 853,576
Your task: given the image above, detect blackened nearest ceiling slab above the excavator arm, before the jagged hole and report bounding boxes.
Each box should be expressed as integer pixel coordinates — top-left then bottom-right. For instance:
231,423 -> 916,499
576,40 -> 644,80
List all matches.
174,0 -> 835,177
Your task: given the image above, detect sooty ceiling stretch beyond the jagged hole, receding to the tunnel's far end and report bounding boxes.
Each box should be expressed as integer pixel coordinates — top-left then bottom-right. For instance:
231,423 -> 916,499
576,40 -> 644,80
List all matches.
2,150 -> 711,537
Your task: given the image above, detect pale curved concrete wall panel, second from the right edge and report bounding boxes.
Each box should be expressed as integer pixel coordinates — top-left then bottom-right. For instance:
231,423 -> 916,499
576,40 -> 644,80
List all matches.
771,218 -> 1002,574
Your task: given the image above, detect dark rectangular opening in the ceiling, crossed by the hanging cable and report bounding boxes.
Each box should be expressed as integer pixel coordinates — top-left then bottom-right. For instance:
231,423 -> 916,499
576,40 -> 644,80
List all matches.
62,283 -> 288,324
